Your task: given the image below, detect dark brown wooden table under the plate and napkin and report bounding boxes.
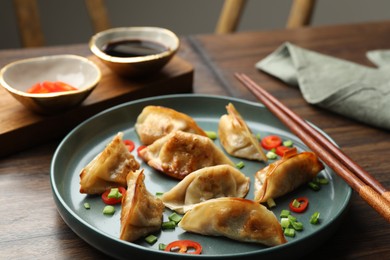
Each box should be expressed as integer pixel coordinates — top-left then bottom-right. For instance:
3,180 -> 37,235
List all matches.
0,21 -> 390,259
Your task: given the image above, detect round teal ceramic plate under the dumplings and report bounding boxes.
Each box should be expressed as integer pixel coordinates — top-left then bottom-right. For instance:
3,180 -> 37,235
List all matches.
50,94 -> 351,259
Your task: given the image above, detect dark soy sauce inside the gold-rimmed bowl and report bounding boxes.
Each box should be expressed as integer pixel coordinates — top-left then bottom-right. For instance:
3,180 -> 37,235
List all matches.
103,40 -> 169,58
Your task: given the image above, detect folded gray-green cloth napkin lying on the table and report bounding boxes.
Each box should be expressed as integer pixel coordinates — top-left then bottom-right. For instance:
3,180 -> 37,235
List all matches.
256,42 -> 390,130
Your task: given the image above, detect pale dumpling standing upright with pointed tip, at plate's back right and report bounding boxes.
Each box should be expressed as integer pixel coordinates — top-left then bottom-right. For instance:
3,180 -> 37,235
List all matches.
218,103 -> 268,162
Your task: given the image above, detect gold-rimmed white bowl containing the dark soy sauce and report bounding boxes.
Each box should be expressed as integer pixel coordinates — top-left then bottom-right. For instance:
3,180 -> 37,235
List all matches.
89,27 -> 180,77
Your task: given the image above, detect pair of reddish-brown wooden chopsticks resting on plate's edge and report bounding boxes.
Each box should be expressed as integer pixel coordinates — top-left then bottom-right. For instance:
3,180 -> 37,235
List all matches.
235,73 -> 390,222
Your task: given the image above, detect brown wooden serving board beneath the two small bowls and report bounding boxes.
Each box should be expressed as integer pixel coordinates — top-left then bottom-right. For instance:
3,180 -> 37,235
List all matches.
0,56 -> 194,157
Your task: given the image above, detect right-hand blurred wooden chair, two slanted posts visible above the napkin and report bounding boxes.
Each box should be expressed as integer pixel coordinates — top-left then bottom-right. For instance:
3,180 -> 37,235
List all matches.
215,0 -> 315,34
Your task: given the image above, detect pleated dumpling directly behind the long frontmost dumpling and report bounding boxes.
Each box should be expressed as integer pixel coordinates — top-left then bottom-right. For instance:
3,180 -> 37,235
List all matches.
161,164 -> 250,214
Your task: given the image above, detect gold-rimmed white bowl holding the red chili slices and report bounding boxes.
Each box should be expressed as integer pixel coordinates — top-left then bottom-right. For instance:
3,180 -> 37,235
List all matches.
0,55 -> 101,114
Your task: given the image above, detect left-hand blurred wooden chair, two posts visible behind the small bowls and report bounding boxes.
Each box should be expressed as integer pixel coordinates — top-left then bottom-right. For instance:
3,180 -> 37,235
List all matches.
13,0 -> 111,47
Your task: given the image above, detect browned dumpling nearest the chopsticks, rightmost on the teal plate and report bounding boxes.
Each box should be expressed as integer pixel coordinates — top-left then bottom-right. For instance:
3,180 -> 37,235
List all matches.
254,148 -> 324,202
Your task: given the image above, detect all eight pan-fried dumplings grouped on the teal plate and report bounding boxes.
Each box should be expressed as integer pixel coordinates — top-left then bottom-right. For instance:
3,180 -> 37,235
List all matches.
80,103 -> 324,249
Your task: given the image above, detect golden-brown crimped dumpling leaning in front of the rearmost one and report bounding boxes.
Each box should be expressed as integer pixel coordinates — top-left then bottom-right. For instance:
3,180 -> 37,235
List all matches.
139,130 -> 234,180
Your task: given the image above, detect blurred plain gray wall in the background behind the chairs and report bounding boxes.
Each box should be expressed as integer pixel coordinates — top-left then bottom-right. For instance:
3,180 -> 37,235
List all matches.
0,0 -> 390,49
